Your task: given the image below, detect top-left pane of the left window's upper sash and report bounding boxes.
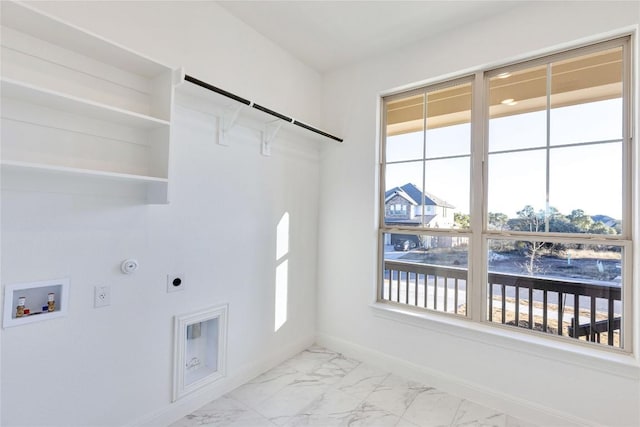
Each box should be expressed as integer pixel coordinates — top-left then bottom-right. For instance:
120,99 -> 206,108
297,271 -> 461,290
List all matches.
385,94 -> 424,162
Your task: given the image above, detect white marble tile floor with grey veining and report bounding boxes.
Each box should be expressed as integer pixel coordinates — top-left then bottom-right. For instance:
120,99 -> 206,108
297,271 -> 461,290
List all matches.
171,346 -> 533,427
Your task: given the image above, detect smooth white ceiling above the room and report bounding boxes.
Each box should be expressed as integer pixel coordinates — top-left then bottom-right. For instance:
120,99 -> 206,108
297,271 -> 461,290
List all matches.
218,1 -> 522,73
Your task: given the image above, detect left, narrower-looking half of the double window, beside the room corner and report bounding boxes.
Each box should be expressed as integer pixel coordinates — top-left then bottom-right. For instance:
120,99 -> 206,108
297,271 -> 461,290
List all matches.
379,78 -> 473,315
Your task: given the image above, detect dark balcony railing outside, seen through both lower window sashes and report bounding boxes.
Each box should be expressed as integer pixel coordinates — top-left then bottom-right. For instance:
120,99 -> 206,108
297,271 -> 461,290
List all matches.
380,260 -> 622,347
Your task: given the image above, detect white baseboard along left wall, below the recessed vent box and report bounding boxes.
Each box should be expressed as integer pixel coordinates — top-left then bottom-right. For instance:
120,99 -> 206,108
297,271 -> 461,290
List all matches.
125,337 -> 314,427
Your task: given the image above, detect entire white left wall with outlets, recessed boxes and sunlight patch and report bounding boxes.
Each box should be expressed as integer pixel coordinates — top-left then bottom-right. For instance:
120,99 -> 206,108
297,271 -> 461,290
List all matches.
0,2 -> 321,426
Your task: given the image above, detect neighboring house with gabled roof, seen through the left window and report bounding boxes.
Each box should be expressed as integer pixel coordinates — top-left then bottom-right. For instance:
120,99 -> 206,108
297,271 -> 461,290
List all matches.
384,183 -> 455,247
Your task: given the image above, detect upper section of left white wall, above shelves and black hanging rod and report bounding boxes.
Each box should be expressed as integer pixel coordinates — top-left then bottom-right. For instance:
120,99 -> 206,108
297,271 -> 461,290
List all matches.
30,0 -> 322,127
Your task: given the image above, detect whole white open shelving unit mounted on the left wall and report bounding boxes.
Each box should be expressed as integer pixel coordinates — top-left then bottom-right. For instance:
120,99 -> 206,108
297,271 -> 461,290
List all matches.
0,1 -> 178,204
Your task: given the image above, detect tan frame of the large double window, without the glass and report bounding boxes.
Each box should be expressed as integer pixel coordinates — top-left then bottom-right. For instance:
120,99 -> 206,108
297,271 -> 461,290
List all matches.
376,33 -> 640,354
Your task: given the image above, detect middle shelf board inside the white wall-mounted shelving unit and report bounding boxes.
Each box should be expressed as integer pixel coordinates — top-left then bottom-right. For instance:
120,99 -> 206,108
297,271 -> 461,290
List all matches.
0,78 -> 169,129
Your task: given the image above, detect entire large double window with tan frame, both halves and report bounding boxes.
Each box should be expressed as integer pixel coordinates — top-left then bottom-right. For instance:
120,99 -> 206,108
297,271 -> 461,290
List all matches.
378,38 -> 636,350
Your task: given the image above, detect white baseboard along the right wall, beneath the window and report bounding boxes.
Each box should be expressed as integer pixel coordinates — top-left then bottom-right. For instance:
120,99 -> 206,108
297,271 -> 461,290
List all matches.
316,334 -> 598,427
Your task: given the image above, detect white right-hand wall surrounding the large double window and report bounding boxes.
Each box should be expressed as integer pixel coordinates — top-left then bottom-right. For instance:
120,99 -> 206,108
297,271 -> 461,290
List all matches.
318,2 -> 640,426
